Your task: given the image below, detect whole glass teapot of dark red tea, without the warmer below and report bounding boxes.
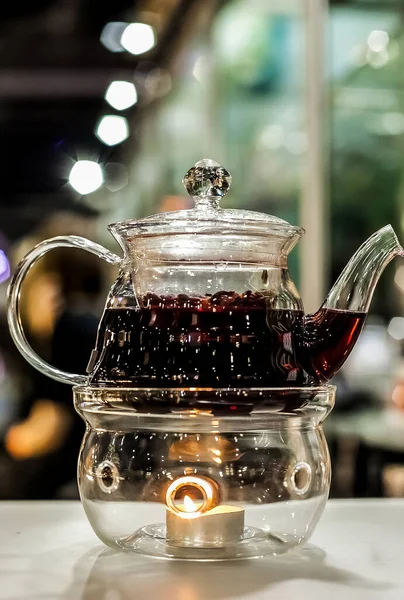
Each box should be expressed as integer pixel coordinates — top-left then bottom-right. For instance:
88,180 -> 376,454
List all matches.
8,159 -> 403,390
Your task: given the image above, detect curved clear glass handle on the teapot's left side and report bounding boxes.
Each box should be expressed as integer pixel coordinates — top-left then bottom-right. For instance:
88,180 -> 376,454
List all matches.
7,235 -> 121,385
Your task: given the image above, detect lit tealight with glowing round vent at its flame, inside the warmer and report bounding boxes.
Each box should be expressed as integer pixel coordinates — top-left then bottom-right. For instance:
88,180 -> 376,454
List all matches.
166,476 -> 244,548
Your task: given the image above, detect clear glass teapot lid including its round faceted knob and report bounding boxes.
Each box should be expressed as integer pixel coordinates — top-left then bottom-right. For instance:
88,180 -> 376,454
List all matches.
109,158 -> 304,238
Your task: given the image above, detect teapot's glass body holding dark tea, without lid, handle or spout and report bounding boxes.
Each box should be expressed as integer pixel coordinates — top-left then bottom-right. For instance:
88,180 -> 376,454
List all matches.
88,225 -> 306,388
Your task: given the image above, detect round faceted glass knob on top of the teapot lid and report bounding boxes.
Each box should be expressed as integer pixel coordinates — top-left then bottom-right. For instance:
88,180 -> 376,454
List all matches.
182,158 -> 232,208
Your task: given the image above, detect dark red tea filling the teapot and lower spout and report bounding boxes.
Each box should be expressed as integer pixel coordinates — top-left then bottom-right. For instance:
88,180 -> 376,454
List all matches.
91,292 -> 365,388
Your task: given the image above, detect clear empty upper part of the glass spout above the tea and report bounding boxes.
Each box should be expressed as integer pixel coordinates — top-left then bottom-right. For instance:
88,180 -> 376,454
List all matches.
322,225 -> 404,313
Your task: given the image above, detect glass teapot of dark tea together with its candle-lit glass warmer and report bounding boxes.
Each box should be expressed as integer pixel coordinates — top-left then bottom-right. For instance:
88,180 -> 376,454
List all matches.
8,159 -> 402,559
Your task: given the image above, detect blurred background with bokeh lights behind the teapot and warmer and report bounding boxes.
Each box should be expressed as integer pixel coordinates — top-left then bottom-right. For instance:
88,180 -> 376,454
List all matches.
0,0 -> 404,498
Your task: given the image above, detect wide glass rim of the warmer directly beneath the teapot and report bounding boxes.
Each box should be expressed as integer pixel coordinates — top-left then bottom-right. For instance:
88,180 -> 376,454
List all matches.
73,385 -> 336,426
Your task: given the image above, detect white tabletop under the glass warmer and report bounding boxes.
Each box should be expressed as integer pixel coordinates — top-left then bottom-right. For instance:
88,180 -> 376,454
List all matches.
0,500 -> 404,600
